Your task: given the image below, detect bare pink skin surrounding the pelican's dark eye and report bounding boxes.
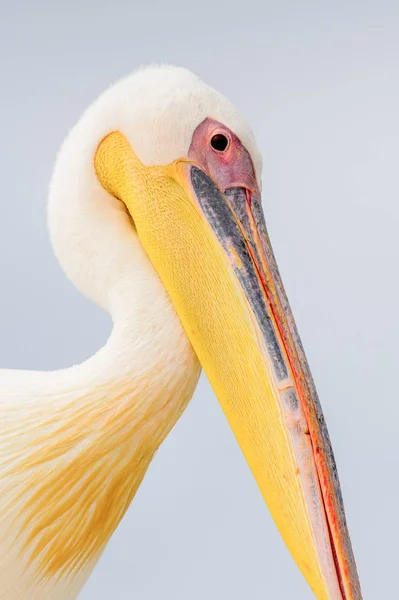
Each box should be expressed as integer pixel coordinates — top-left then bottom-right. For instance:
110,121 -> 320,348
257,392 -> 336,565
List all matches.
188,118 -> 260,198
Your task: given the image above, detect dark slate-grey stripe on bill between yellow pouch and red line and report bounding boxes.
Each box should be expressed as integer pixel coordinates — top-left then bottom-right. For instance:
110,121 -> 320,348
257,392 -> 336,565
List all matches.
191,166 -> 288,381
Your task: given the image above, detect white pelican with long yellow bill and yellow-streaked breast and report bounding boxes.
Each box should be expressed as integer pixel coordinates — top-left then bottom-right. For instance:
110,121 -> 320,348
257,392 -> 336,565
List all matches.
0,66 -> 361,600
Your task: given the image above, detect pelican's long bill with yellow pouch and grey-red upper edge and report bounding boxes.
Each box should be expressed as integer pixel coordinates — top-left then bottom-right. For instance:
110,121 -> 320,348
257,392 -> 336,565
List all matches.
95,127 -> 361,600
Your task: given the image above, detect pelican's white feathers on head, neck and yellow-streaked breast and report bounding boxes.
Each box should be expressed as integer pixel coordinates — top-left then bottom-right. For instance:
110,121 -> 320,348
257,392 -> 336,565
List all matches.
0,67 -> 260,600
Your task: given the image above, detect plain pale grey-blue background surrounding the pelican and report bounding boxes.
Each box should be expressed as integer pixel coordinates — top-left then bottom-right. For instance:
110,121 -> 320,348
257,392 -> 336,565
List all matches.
0,0 -> 399,600
